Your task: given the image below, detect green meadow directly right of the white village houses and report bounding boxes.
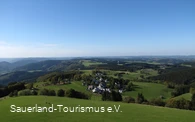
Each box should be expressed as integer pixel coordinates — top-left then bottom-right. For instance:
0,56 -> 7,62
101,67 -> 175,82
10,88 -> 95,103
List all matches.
123,82 -> 172,100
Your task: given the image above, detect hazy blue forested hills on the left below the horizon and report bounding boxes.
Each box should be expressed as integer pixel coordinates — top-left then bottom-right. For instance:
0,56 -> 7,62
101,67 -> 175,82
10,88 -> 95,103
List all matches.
0,60 -> 84,85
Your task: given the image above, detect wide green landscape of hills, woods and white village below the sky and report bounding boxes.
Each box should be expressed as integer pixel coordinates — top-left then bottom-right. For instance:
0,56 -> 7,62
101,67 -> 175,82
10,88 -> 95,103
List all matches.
0,58 -> 195,122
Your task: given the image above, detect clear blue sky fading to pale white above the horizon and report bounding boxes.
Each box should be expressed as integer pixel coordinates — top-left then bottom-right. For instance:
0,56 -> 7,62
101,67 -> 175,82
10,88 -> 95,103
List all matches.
0,0 -> 195,57
